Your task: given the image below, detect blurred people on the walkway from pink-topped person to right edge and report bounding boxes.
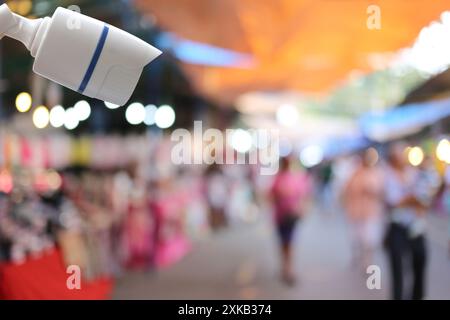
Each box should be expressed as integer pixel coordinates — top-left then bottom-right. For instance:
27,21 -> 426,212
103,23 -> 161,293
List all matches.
271,142 -> 450,299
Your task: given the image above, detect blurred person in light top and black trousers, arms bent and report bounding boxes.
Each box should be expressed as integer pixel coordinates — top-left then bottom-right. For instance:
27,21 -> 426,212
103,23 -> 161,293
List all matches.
385,143 -> 427,300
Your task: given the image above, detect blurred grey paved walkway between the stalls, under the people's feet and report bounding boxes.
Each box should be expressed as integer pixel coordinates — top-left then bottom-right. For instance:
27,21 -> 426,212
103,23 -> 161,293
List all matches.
114,206 -> 450,299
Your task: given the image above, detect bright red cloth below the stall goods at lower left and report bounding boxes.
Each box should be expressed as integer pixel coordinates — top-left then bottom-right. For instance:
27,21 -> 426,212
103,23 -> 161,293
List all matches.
0,249 -> 113,300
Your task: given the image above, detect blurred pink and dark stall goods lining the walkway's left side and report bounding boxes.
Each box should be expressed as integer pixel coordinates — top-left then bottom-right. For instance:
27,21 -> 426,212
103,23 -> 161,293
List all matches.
0,134 -> 264,280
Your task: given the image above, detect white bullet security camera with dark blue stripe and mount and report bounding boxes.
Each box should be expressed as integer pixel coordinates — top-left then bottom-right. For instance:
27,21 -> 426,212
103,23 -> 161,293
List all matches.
0,4 -> 161,105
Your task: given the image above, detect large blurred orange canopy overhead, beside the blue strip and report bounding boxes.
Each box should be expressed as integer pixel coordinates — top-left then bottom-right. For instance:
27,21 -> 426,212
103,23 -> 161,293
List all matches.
136,0 -> 450,101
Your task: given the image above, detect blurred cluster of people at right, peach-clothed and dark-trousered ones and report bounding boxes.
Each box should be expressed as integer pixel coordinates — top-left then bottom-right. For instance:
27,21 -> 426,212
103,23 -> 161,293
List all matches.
324,142 -> 450,299
